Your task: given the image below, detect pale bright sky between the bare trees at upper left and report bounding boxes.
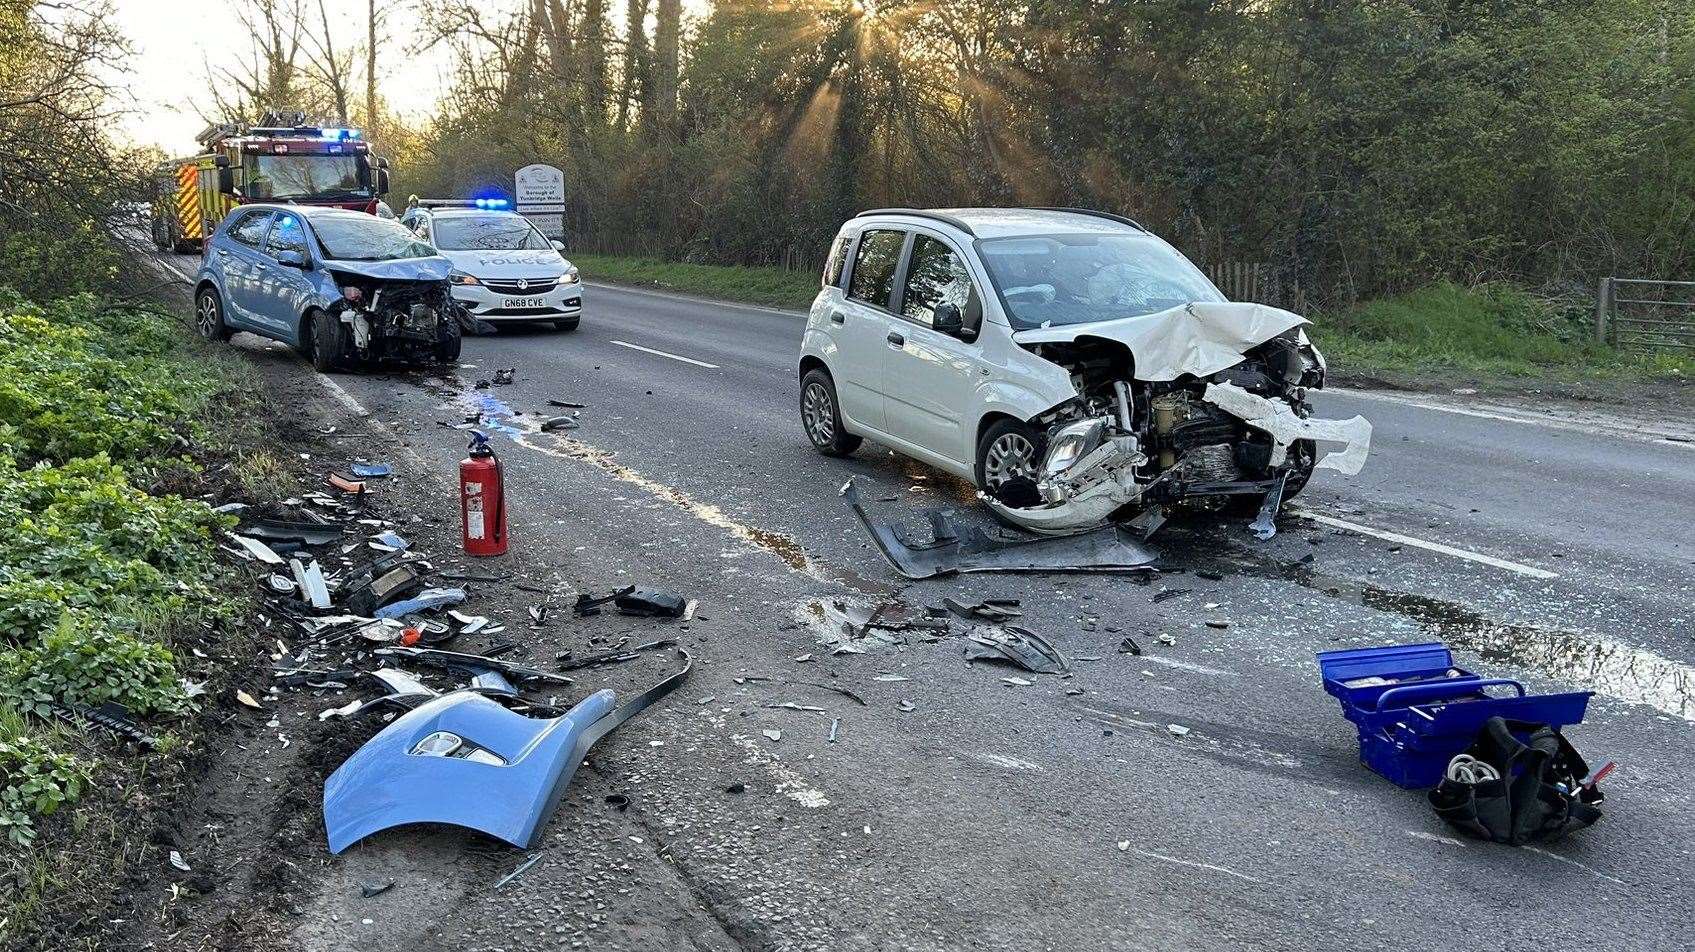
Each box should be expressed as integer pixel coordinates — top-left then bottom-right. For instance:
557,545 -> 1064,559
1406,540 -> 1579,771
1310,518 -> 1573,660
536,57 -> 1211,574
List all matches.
112,0 -> 464,149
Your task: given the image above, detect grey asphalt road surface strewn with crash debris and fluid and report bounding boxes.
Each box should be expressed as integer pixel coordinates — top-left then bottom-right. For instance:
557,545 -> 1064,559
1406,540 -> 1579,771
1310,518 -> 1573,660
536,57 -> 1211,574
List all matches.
149,245 -> 1695,950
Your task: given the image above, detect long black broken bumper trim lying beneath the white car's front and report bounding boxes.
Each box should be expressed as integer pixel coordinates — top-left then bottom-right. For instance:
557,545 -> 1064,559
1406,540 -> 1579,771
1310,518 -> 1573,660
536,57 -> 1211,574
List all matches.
841,479 -> 1154,579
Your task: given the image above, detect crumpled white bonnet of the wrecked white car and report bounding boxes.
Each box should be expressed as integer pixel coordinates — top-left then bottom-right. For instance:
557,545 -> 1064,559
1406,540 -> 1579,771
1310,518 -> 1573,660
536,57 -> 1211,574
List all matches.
1012,302 -> 1310,381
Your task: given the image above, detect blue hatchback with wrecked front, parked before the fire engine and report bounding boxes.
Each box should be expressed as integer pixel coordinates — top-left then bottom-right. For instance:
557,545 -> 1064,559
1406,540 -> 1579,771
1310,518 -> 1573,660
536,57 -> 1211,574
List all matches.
195,205 -> 461,371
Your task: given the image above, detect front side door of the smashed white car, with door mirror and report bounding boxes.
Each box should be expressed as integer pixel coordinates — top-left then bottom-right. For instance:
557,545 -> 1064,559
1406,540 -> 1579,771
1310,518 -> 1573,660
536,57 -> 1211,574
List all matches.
883,230 -> 986,466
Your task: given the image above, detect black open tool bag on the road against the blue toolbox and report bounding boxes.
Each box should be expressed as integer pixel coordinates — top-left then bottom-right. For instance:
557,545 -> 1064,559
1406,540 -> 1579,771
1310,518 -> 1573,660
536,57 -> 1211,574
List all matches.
1431,717 -> 1603,845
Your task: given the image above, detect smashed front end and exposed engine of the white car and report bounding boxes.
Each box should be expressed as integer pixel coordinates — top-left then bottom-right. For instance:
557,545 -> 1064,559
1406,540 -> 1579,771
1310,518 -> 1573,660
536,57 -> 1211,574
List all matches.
985,305 -> 1371,534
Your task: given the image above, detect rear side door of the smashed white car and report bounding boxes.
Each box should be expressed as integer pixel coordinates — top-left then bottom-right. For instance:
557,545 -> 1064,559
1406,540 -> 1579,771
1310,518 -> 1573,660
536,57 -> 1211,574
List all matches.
829,227 -> 907,430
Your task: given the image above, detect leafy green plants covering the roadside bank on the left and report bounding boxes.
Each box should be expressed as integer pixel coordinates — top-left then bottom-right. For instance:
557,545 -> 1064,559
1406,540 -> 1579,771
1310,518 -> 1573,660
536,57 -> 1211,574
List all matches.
0,281 -> 271,949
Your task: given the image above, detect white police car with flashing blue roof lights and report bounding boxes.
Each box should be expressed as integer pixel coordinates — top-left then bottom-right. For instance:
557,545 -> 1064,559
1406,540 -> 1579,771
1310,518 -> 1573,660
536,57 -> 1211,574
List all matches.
400,198 -> 583,330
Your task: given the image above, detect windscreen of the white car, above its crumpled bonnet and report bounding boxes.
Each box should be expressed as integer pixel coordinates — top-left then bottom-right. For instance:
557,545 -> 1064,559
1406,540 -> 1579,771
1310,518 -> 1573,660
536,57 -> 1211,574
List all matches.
978,234 -> 1224,330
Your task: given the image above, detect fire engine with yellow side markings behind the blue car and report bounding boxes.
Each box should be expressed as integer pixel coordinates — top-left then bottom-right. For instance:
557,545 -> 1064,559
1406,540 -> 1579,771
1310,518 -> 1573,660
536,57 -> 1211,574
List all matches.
153,112 -> 388,252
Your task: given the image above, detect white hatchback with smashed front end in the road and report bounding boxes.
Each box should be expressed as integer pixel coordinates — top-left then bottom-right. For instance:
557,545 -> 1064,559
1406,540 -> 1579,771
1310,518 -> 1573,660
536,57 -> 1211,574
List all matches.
800,208 -> 1371,534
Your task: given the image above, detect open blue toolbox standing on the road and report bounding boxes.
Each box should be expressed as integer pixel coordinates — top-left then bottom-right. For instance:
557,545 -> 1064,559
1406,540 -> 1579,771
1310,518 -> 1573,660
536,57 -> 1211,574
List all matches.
1319,642 -> 1595,789
